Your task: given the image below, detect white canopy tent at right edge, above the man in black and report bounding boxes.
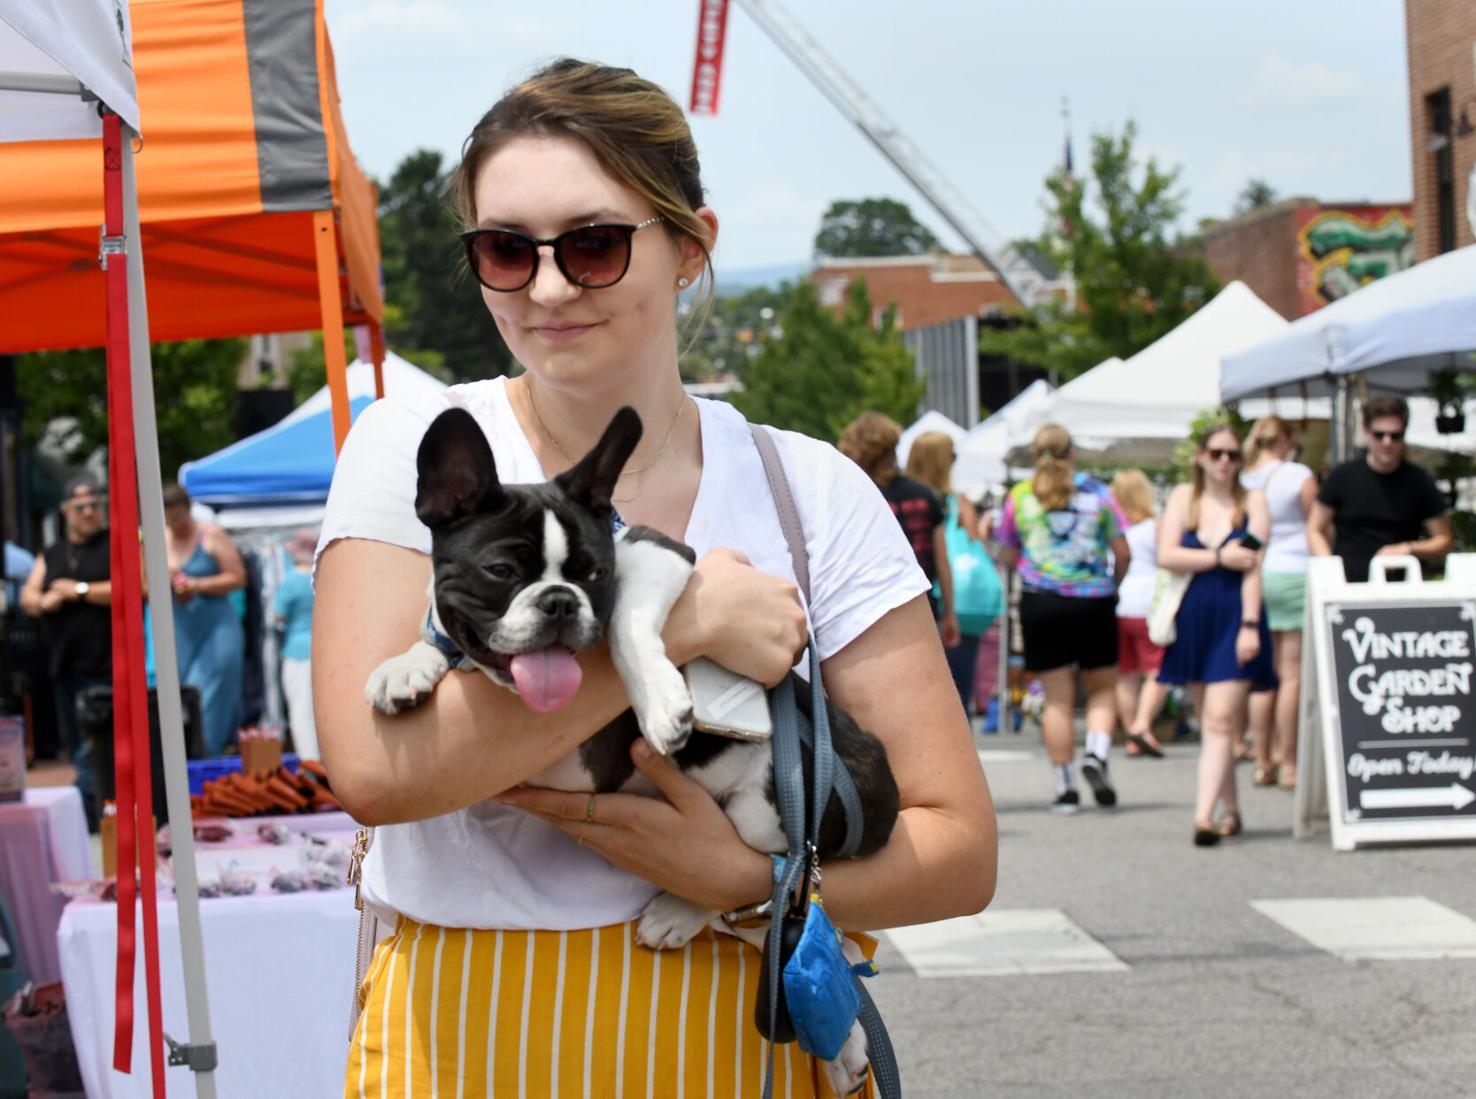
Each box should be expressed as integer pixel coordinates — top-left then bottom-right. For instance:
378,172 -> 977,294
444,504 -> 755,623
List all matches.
1221,245 -> 1476,400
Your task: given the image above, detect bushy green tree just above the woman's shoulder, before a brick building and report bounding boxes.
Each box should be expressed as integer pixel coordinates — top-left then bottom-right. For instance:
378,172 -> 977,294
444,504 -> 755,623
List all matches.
732,279 -> 925,440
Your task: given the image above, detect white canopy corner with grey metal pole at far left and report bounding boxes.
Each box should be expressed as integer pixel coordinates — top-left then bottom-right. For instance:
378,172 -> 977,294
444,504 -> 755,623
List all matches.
0,0 -> 215,1098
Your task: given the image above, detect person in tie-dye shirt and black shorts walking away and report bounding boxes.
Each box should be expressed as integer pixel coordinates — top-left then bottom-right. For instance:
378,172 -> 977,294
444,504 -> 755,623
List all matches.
995,423 -> 1131,813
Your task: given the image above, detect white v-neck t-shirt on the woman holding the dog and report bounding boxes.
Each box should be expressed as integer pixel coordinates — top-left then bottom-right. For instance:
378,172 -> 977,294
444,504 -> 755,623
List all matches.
319,378 -> 928,931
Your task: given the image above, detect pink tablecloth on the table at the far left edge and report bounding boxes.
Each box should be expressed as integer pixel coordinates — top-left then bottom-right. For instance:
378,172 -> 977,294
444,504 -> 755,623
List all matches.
0,786 -> 97,984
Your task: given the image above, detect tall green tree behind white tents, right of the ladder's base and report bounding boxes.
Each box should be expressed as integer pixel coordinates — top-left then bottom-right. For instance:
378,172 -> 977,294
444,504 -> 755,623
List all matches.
980,121 -> 1219,378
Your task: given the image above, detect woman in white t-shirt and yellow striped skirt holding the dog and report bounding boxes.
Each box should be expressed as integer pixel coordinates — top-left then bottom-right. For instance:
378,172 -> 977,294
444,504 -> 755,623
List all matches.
313,60 -> 995,1095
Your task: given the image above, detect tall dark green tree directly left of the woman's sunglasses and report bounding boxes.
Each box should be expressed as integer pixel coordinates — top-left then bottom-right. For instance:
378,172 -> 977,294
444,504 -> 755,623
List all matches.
379,149 -> 512,381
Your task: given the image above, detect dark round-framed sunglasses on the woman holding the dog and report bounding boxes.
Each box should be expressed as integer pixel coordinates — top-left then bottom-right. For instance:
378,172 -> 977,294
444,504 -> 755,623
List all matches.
461,217 -> 663,294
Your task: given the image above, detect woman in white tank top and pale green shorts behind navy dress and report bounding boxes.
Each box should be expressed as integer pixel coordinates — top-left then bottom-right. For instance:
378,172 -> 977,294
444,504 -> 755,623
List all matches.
1240,416 -> 1317,789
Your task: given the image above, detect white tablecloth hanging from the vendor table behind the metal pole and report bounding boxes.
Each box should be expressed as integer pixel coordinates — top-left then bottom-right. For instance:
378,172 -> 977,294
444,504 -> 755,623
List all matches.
56,890 -> 359,1099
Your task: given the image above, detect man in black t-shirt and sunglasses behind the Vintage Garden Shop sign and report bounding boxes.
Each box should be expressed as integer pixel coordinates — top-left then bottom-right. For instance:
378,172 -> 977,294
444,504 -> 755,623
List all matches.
1306,397 -> 1451,583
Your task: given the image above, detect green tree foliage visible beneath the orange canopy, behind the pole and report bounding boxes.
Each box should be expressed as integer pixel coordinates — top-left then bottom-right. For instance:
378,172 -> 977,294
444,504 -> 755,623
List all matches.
16,339 -> 246,479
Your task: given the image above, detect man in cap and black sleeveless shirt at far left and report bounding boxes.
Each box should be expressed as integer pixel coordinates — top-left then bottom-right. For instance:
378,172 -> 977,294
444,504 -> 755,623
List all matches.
21,474 -> 112,829
